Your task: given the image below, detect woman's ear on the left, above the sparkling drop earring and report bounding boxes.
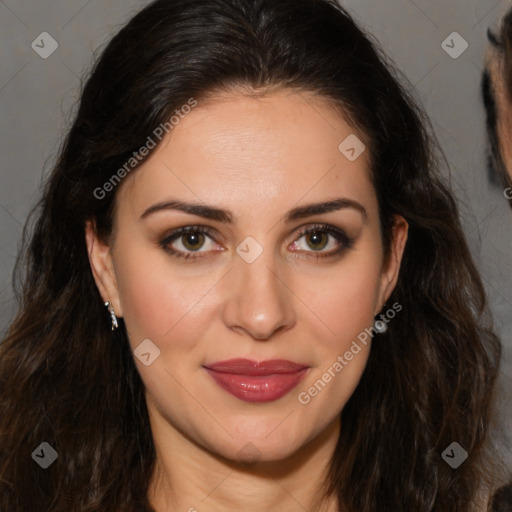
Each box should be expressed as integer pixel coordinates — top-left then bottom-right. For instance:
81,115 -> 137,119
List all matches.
85,221 -> 123,317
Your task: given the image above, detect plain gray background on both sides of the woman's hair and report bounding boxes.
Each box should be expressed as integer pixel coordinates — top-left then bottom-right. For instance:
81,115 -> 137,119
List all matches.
0,0 -> 512,472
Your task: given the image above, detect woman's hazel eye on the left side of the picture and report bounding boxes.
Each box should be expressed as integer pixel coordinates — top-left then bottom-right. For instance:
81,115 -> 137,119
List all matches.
159,226 -> 216,259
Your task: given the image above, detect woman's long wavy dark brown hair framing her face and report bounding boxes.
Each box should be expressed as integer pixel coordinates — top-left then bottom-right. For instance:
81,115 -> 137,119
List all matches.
0,0 -> 500,512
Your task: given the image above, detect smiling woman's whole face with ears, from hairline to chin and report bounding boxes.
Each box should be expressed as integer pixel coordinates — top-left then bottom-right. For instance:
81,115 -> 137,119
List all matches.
87,91 -> 407,460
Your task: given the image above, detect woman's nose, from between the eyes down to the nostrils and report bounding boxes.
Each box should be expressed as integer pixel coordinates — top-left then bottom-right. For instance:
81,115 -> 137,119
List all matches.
224,247 -> 296,341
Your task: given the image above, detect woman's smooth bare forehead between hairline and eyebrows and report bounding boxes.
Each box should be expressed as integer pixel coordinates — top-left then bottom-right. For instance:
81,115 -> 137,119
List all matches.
120,90 -> 373,215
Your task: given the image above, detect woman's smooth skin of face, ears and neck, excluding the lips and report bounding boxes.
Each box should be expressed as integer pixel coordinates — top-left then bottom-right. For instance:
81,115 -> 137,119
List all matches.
86,90 -> 407,512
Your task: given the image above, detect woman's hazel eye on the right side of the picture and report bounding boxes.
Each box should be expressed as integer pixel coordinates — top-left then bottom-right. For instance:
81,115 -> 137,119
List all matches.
291,224 -> 354,257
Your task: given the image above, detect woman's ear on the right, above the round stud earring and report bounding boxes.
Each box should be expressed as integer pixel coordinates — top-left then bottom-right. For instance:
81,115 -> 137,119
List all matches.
375,215 -> 409,315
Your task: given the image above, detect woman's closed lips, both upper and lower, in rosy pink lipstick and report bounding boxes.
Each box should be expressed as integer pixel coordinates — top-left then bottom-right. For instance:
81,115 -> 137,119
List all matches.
204,359 -> 309,402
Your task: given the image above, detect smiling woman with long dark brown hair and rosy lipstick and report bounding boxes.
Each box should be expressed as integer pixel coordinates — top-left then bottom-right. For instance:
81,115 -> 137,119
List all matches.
0,0 -> 500,512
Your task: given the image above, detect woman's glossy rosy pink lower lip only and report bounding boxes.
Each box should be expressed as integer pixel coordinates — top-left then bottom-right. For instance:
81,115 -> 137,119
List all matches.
205,368 -> 309,402
